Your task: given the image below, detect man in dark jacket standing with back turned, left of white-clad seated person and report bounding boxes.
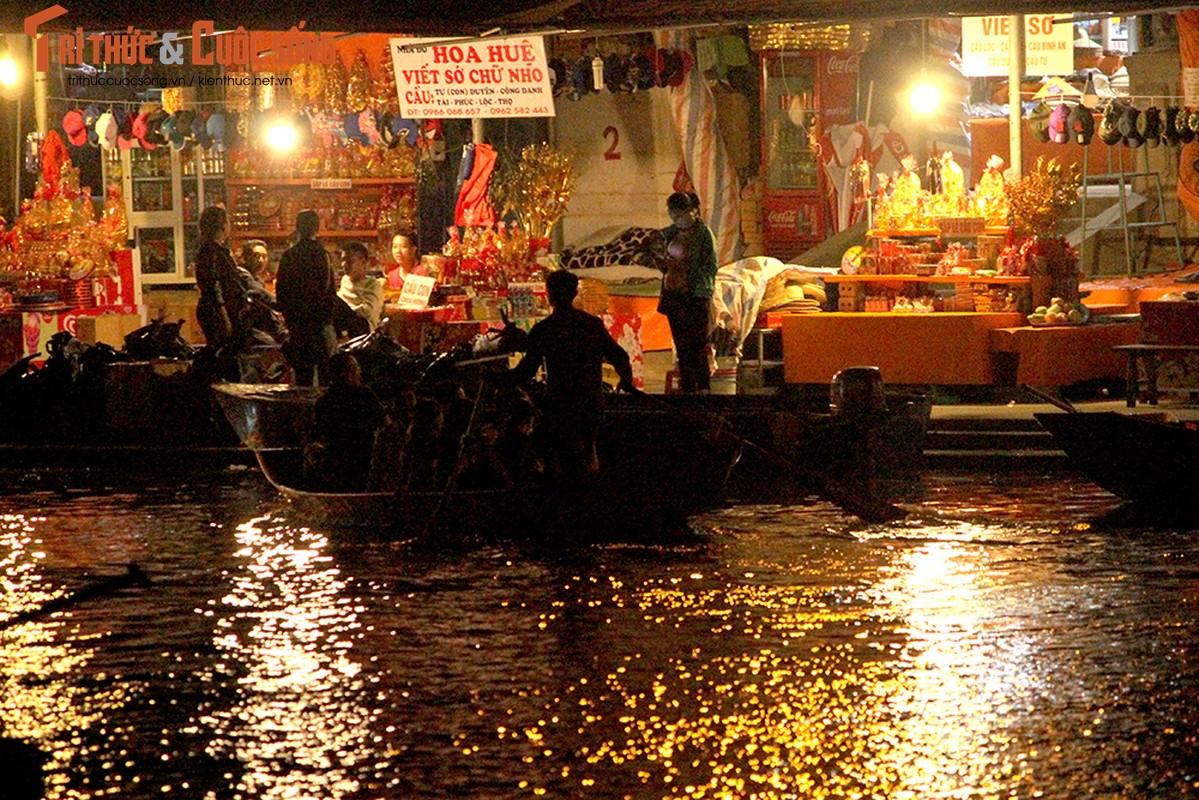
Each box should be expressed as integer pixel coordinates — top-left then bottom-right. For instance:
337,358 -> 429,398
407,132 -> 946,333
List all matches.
275,209 -> 337,386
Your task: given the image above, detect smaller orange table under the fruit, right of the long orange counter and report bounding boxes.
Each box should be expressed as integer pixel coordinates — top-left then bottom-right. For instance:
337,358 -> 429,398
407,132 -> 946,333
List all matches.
990,325 -> 1140,386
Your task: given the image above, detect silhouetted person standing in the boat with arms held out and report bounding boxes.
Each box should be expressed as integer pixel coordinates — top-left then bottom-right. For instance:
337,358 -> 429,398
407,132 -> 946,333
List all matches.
501,270 -> 639,477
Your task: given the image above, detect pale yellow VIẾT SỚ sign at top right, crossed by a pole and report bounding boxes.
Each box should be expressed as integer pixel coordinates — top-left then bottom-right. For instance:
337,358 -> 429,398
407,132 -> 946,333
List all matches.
962,14 -> 1074,78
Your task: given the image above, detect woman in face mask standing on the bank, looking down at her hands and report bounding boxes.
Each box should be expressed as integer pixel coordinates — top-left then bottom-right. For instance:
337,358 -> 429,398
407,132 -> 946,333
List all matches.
658,192 -> 716,393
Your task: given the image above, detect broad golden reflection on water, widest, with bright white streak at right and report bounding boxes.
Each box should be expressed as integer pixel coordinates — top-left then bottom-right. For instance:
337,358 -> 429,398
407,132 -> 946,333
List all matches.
513,524 -> 1131,800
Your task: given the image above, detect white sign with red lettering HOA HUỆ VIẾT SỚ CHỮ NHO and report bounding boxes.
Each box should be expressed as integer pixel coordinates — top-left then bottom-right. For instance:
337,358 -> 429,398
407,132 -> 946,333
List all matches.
391,36 -> 554,120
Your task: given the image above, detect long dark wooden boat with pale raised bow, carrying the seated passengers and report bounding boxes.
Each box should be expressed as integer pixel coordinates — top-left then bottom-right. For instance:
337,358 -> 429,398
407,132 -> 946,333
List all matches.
213,384 -> 737,535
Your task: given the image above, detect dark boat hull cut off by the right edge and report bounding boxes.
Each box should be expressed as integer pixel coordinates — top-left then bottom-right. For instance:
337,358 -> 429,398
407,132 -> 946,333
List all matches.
1036,411 -> 1199,506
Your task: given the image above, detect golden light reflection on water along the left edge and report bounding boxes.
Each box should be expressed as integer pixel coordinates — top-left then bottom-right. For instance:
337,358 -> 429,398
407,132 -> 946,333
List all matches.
0,515 -> 129,800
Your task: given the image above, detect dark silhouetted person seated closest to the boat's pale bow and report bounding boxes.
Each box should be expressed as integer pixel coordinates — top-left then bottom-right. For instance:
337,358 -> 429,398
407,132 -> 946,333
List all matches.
305,351 -> 387,492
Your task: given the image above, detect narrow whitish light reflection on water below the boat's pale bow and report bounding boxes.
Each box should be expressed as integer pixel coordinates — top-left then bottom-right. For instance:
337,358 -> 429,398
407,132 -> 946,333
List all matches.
188,517 -> 387,800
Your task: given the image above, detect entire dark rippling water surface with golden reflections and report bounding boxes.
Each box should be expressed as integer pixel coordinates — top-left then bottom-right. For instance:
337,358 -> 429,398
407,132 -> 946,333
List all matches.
0,470 -> 1199,800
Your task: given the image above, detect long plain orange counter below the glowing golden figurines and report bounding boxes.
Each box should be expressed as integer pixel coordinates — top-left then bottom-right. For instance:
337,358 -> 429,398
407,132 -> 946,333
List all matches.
782,312 -> 1024,385
